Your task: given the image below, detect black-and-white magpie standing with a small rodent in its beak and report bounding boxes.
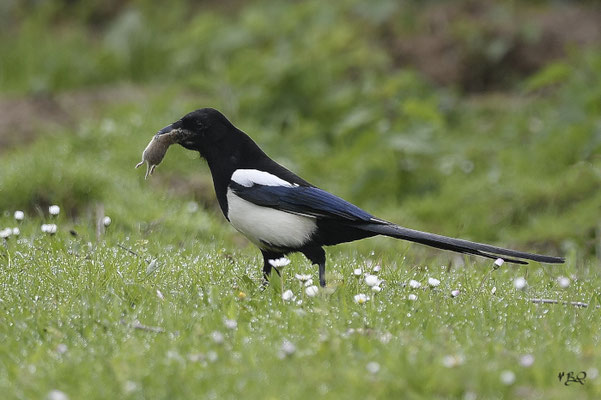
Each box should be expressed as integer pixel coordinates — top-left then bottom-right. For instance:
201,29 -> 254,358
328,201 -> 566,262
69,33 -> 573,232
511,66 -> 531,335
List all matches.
148,108 -> 564,287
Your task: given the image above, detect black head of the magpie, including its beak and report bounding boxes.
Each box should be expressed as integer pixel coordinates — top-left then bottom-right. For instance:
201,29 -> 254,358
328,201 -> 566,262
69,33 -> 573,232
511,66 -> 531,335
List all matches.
157,108 -> 238,158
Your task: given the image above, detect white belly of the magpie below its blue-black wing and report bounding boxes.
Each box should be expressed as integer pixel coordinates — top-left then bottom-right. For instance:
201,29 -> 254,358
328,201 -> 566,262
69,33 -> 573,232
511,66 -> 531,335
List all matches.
227,189 -> 317,248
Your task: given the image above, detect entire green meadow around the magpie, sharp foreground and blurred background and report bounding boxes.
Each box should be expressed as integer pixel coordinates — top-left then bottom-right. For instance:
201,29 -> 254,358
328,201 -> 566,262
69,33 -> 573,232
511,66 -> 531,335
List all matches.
0,0 -> 601,400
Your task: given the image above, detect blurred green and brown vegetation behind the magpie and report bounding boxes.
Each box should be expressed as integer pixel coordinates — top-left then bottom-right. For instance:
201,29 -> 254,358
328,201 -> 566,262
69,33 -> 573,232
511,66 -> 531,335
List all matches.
0,0 -> 601,259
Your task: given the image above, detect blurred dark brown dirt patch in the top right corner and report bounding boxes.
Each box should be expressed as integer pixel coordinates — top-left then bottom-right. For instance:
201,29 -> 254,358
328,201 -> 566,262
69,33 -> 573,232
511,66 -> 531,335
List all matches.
383,1 -> 601,91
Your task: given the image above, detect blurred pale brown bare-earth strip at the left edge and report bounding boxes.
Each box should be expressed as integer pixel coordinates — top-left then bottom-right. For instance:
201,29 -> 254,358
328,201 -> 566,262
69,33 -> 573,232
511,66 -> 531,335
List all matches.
0,86 -> 144,151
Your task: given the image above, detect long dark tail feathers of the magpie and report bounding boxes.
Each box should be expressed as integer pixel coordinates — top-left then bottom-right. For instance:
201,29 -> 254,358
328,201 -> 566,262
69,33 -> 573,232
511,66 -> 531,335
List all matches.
361,222 -> 565,264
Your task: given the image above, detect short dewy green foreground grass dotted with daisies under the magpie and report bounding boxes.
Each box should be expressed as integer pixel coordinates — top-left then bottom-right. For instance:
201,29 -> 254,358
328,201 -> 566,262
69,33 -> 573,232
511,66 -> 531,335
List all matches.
0,223 -> 601,399
